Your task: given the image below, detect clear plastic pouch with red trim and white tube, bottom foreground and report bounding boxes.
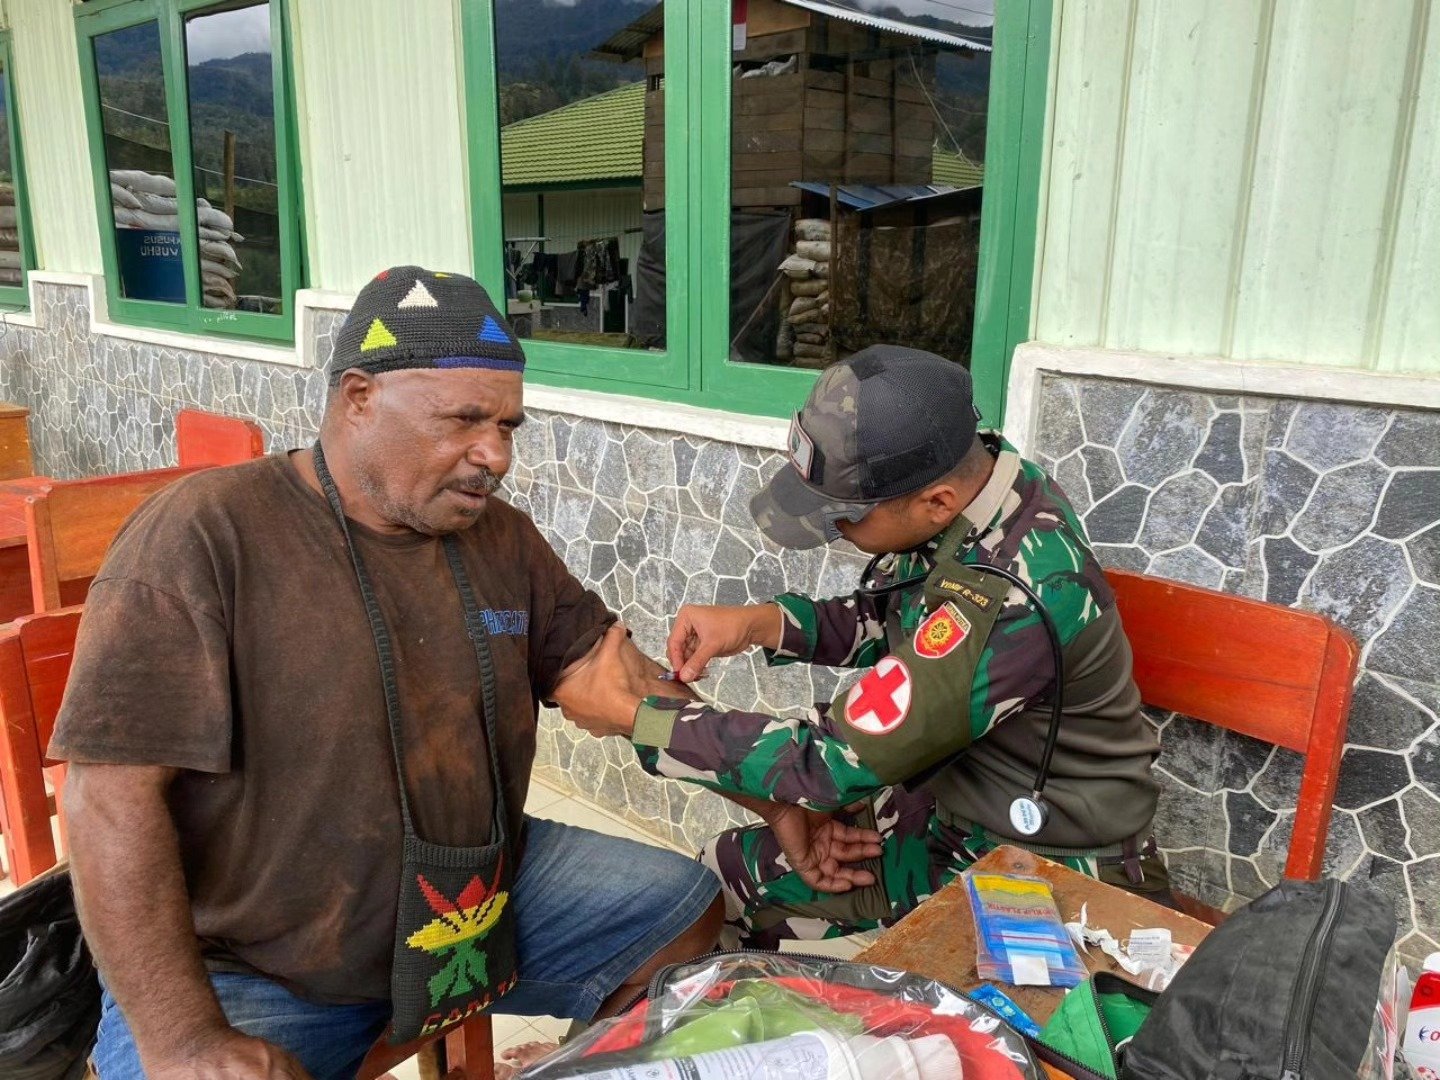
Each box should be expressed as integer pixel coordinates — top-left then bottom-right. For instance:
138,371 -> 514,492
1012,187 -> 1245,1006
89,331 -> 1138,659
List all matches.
523,952 -> 1043,1080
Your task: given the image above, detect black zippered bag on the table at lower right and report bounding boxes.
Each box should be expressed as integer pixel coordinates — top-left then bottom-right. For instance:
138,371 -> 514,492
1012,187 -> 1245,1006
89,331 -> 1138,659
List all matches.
1122,880 -> 1395,1080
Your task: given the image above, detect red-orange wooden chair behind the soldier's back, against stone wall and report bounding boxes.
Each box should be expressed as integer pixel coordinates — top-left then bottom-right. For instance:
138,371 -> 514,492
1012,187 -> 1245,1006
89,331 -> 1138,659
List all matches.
1106,570 -> 1359,881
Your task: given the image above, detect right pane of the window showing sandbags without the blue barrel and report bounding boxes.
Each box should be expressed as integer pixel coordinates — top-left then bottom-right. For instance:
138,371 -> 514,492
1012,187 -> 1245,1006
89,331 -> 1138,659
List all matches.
184,4 -> 284,314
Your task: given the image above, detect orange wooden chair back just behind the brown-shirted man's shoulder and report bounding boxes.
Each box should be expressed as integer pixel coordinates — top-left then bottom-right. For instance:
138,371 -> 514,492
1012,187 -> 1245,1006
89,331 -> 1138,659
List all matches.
24,468 -> 199,612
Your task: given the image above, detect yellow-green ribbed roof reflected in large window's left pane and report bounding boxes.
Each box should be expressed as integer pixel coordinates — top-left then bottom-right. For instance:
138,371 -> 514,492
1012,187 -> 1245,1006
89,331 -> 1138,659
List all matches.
500,82 -> 645,187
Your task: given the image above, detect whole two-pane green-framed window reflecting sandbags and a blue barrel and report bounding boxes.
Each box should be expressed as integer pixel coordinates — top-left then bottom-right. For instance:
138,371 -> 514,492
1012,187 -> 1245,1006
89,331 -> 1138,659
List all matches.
75,0 -> 302,341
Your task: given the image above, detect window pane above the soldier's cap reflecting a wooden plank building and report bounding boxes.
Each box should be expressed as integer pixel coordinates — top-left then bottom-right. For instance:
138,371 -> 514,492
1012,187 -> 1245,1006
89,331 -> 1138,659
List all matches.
730,0 -> 994,367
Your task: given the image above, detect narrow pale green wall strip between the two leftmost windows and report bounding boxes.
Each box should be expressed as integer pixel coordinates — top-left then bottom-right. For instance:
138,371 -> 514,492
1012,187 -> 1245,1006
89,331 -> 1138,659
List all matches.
3,0 -> 104,274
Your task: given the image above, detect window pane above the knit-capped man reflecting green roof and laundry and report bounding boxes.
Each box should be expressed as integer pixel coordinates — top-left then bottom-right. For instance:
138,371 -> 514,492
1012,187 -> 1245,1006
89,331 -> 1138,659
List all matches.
495,0 -> 665,348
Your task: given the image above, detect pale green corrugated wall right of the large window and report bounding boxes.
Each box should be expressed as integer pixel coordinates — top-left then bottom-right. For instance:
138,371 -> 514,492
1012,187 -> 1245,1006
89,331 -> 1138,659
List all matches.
1034,0 -> 1440,372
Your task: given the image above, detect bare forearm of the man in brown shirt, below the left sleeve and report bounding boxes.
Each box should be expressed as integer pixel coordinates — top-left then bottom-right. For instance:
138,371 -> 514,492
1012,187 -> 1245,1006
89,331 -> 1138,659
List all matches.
65,765 -> 229,1067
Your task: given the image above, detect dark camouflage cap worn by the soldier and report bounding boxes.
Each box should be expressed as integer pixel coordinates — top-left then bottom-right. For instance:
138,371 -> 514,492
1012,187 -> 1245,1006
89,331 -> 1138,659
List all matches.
750,346 -> 979,549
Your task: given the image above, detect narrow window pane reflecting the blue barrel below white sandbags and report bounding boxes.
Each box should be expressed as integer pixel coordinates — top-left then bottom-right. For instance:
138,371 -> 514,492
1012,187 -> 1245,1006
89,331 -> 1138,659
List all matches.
94,23 -> 184,304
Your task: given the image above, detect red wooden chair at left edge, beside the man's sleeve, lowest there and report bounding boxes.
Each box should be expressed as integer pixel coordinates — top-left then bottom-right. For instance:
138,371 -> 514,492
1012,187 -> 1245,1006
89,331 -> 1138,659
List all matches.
0,608 -> 81,886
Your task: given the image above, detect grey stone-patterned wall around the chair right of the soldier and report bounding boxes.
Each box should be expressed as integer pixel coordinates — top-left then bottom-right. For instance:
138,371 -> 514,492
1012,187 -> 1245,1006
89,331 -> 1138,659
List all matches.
1035,377 -> 1440,955
